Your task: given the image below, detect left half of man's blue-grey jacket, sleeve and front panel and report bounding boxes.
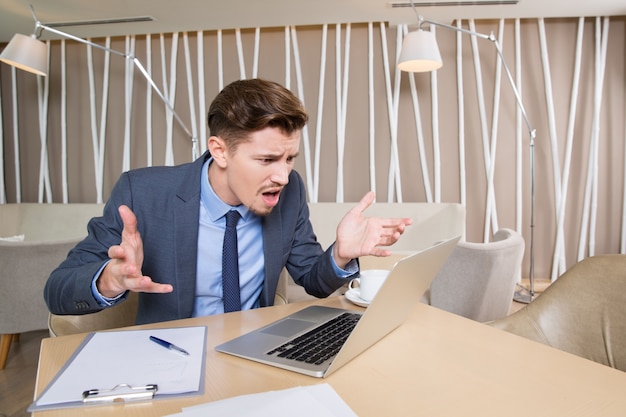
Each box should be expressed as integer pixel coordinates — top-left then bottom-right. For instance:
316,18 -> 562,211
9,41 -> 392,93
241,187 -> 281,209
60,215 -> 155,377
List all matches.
44,155 -> 208,323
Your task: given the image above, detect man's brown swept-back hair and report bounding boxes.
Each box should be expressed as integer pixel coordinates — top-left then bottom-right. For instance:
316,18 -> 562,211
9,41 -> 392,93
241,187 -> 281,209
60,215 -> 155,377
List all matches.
207,78 -> 309,150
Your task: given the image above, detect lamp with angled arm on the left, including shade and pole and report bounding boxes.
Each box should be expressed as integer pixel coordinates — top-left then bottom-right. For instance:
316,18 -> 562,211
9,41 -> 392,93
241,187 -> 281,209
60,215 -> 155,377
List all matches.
0,5 -> 198,160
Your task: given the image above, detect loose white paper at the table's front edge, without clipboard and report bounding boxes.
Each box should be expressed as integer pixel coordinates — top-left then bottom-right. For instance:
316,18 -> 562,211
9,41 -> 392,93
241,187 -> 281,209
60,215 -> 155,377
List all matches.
168,384 -> 357,417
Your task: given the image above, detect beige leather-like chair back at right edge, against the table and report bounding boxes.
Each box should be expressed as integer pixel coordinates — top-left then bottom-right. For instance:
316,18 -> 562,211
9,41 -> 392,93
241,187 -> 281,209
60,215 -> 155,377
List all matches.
489,255 -> 626,371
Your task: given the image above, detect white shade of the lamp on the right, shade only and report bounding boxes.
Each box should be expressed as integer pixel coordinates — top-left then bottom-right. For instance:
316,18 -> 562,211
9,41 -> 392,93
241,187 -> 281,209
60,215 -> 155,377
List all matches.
398,30 -> 443,72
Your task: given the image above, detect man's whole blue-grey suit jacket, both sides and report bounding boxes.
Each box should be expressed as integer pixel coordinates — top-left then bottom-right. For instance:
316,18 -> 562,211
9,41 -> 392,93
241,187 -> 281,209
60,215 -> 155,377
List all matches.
44,153 -> 346,324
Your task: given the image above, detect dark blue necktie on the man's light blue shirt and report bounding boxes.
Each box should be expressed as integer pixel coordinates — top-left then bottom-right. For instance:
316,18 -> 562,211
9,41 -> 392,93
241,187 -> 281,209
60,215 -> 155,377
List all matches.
222,210 -> 241,313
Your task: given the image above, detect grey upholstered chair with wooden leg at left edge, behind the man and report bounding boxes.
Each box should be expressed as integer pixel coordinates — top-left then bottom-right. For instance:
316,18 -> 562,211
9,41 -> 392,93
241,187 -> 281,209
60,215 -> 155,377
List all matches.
0,239 -> 78,369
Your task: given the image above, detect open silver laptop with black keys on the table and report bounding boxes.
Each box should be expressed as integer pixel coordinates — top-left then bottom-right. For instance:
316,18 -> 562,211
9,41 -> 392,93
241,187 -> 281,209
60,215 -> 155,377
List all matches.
215,236 -> 460,377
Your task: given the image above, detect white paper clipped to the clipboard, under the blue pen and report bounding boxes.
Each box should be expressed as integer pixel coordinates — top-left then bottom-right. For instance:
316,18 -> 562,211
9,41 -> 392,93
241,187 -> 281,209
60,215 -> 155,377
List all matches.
35,327 -> 206,406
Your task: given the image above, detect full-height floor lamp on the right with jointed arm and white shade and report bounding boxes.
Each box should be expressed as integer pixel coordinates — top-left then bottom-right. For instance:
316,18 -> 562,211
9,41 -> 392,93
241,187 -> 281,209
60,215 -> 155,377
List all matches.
398,0 -> 536,303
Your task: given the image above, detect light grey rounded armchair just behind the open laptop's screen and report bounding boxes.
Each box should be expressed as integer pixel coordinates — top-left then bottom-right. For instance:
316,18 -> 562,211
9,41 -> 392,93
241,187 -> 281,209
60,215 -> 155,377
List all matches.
423,229 -> 524,322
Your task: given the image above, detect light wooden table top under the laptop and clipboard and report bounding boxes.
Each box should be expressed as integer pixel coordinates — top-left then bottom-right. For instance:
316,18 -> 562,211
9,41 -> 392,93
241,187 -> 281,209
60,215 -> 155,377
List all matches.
34,296 -> 626,417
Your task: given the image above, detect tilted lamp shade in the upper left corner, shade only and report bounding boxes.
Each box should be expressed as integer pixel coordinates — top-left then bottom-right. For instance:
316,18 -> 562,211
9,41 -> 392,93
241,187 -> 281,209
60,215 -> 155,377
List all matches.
0,33 -> 48,76
